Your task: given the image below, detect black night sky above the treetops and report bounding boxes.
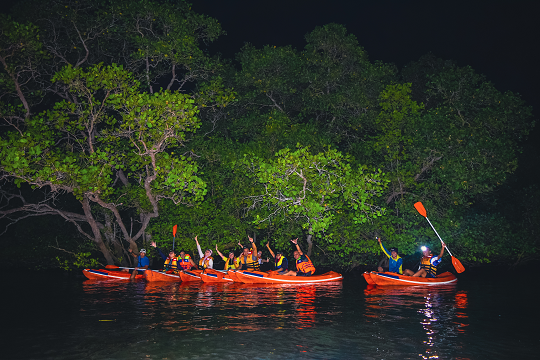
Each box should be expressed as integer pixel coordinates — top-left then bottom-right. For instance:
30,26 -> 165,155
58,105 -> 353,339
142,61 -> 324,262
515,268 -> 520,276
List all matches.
1,0 -> 540,182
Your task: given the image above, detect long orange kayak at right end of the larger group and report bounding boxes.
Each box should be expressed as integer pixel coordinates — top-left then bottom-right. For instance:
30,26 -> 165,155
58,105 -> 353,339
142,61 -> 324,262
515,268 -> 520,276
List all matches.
236,270 -> 343,284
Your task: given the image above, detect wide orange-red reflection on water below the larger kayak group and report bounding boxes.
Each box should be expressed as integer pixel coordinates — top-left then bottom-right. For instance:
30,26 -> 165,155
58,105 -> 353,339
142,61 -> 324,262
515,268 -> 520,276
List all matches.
83,280 -> 342,332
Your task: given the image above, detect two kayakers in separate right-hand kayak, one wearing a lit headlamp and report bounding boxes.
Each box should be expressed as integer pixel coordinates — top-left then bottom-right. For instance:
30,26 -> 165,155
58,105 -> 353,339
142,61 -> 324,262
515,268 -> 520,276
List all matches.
376,238 -> 446,278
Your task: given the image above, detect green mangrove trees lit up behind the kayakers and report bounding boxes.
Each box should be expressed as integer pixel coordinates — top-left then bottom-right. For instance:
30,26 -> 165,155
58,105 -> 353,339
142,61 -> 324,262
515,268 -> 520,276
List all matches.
0,0 -> 540,272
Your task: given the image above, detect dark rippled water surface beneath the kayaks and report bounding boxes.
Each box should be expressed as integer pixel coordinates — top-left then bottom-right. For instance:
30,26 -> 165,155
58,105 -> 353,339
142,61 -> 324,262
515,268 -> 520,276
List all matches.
0,272 -> 540,359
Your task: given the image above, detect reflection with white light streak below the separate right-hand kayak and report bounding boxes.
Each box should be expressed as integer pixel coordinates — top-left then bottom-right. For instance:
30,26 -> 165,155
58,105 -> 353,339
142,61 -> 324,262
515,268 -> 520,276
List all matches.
364,285 -> 468,359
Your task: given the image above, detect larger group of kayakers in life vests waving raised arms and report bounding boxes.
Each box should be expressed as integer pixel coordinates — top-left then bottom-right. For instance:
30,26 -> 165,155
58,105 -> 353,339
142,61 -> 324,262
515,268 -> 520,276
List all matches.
129,236 -> 315,278
